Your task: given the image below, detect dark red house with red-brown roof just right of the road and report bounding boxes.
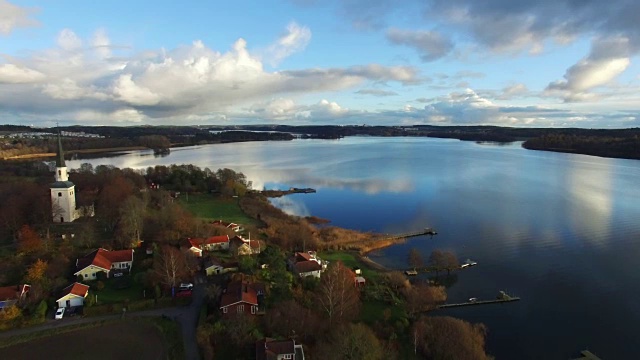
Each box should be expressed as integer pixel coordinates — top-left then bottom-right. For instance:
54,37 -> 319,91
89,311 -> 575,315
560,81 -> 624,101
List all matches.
220,281 -> 264,316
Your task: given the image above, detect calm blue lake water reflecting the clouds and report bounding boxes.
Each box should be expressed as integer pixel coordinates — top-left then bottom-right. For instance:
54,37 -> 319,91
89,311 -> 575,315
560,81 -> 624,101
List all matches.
67,137 -> 640,359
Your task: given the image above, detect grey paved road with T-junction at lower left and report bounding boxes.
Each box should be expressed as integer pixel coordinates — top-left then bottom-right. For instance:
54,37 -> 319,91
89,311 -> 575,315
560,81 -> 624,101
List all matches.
0,275 -> 207,360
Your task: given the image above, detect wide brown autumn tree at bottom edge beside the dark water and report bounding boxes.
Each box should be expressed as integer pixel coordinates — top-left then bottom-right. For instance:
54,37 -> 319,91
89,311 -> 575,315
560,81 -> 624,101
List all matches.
411,316 -> 489,360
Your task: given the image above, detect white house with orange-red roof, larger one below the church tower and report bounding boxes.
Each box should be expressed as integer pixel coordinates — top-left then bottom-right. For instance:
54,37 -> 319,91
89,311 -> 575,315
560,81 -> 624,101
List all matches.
73,248 -> 133,280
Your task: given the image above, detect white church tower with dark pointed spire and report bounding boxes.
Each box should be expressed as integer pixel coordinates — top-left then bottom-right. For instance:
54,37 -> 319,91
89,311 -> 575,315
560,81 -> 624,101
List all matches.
51,132 -> 79,223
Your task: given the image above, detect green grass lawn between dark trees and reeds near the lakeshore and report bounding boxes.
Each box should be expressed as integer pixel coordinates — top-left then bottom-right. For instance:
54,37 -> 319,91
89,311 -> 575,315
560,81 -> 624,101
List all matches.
179,194 -> 256,225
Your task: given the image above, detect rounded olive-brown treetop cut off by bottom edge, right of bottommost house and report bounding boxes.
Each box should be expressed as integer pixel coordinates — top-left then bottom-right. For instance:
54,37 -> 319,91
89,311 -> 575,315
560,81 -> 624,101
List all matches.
325,323 -> 385,360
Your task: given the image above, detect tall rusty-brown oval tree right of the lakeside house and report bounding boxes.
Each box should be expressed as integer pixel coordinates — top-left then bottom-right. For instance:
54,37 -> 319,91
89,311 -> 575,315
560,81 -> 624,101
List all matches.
317,261 -> 360,326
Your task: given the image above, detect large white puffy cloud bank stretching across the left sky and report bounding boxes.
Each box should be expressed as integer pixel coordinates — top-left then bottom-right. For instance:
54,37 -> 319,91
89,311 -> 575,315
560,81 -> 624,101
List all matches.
0,22 -> 421,122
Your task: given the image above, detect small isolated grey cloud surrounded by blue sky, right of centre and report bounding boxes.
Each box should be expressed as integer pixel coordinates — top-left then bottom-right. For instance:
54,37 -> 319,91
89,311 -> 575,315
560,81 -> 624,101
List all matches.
387,28 -> 453,61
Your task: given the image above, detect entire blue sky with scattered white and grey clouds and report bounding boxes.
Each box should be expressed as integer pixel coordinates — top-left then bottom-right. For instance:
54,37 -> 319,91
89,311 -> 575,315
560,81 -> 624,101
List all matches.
0,0 -> 640,128
